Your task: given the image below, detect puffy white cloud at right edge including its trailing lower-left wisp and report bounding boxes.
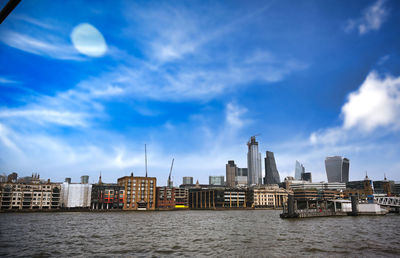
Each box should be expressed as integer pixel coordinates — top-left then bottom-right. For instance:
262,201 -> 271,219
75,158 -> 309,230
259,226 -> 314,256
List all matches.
309,71 -> 400,145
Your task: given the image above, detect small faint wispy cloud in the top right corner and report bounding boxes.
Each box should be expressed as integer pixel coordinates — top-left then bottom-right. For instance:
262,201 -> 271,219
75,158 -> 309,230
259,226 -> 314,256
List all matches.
345,0 -> 389,35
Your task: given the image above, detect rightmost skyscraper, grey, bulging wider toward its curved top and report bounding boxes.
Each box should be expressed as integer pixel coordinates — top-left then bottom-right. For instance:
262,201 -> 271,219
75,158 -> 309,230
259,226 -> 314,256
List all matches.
325,156 -> 350,183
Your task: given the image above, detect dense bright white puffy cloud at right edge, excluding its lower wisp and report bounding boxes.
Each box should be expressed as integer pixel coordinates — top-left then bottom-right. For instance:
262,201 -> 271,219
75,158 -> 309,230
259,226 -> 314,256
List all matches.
342,71 -> 400,131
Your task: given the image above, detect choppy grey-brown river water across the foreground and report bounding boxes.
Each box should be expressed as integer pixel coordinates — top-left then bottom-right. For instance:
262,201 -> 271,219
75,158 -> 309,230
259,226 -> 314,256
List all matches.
0,210 -> 400,257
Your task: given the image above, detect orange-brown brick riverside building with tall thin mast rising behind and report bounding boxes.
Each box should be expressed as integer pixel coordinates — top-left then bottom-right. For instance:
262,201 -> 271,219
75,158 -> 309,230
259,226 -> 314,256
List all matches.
118,173 -> 157,210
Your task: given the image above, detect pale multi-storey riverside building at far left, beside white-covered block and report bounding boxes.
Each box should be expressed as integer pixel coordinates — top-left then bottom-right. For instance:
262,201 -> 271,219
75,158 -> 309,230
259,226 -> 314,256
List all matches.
0,174 -> 61,210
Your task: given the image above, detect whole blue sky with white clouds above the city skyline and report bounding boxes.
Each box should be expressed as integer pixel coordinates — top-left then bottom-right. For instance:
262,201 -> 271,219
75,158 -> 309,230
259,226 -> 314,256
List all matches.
0,0 -> 400,185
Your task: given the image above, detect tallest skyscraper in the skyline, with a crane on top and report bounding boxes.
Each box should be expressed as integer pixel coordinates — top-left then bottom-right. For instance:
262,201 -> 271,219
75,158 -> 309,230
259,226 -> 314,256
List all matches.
247,136 -> 262,185
